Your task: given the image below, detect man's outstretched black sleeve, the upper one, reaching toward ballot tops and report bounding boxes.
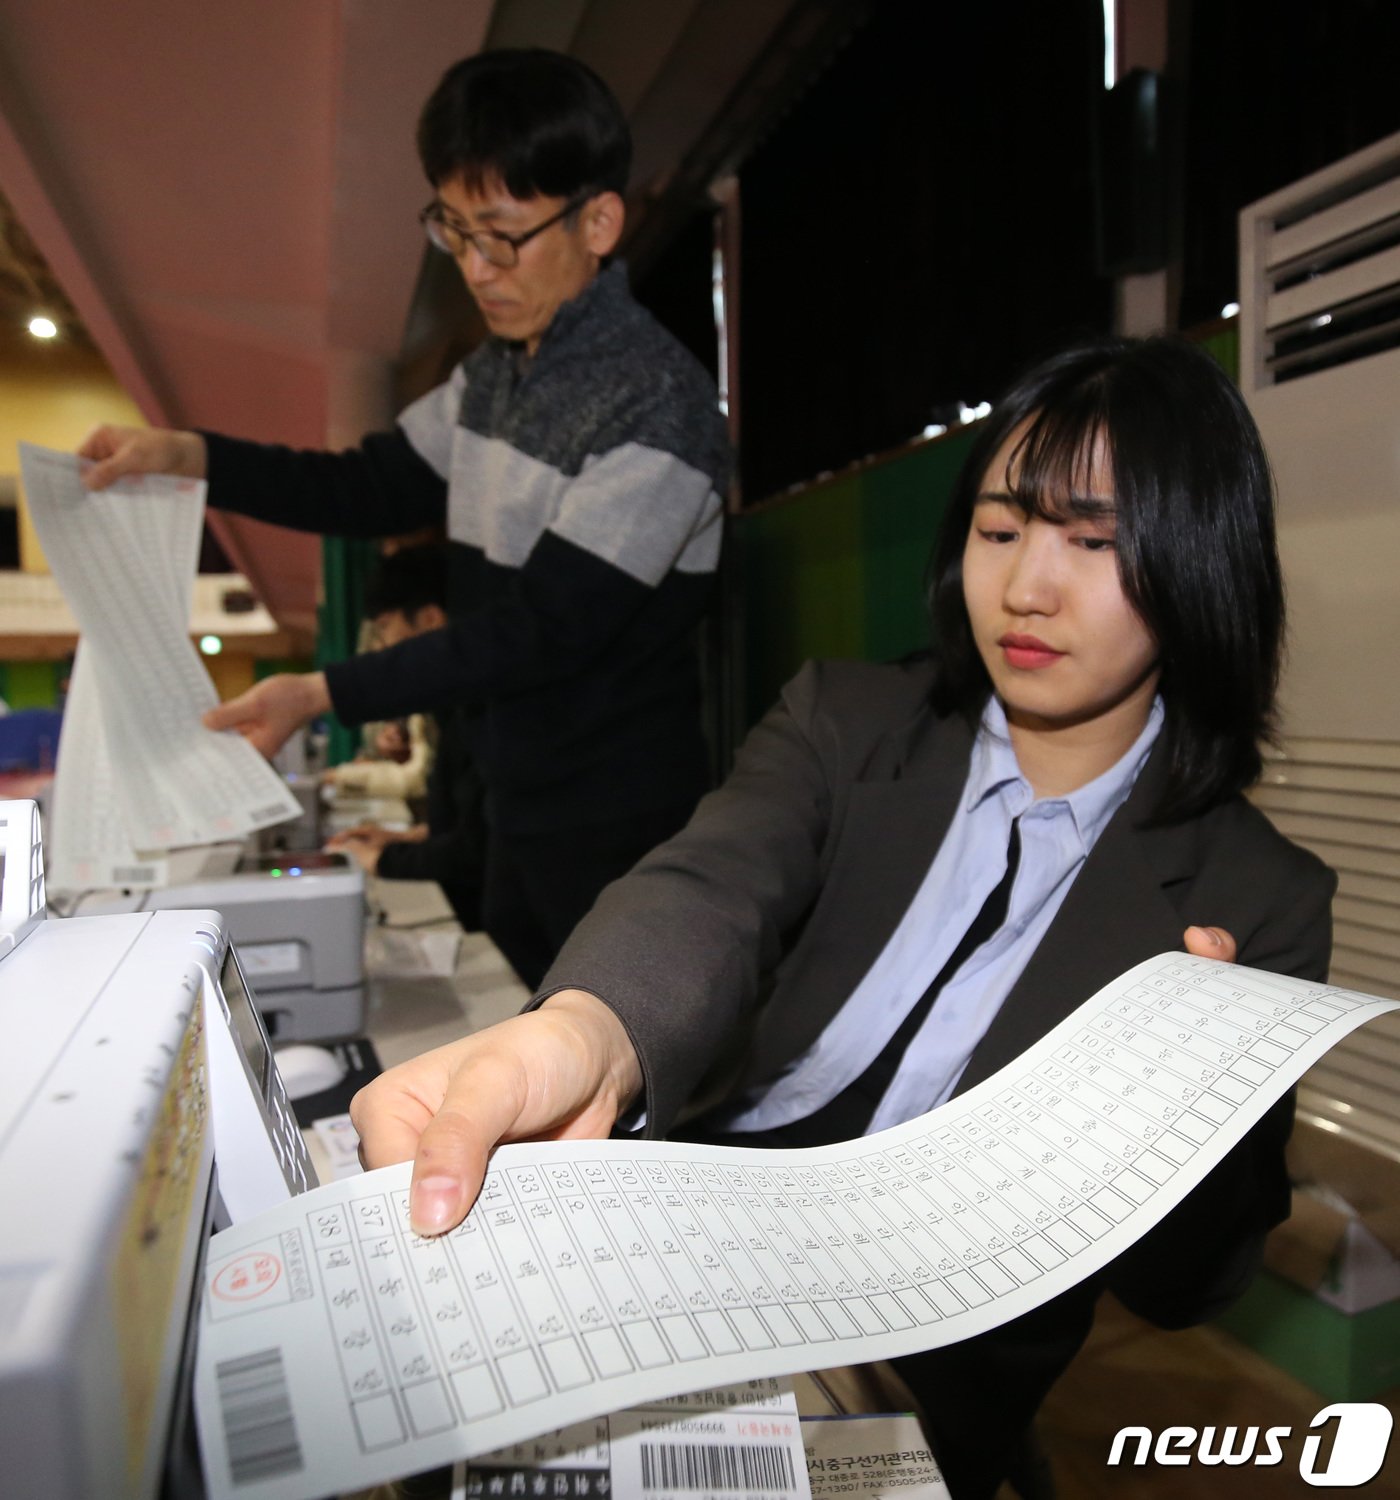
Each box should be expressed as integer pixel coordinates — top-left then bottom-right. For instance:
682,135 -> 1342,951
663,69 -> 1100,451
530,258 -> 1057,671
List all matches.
201,371 -> 464,537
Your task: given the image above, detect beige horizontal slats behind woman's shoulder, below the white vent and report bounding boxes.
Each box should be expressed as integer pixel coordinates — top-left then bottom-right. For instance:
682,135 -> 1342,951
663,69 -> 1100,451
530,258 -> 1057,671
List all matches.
1253,740 -> 1400,1160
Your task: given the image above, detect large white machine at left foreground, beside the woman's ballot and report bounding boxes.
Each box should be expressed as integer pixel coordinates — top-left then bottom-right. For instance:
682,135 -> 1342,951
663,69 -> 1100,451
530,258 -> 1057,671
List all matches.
0,803 -> 315,1500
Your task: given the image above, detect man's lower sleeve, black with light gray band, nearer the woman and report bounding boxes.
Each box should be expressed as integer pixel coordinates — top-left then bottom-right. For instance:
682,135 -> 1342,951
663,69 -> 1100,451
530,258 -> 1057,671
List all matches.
326,423 -> 722,723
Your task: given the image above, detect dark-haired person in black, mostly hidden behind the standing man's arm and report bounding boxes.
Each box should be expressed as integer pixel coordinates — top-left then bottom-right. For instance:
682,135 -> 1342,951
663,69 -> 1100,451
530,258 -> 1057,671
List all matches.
327,545 -> 486,932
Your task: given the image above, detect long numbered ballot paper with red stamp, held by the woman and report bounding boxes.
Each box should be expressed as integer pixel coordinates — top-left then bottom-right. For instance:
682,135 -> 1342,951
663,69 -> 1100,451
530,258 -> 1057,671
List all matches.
195,954 -> 1400,1500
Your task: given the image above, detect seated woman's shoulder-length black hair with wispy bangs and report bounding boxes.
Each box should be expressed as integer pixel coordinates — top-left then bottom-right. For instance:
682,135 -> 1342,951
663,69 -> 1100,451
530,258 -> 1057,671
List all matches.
930,338 -> 1283,822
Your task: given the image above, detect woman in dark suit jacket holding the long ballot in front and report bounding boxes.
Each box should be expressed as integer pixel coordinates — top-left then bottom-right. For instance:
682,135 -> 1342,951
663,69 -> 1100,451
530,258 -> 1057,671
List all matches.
353,339 -> 1335,1500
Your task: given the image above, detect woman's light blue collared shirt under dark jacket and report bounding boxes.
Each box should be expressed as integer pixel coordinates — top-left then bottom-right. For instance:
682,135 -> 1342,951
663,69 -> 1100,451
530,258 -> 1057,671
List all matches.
716,698 -> 1163,1133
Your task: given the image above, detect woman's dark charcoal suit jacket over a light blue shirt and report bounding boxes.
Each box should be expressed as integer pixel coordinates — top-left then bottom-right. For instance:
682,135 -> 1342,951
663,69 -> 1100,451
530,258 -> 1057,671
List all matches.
542,663 -> 1335,1325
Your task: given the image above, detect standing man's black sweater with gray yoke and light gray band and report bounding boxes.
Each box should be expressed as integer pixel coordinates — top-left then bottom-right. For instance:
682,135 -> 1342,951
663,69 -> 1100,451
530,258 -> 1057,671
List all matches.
206,263 -> 729,834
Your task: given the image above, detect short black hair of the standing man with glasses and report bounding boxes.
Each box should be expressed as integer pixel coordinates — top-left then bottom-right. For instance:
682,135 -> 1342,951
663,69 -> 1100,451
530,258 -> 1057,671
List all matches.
419,47 -> 632,200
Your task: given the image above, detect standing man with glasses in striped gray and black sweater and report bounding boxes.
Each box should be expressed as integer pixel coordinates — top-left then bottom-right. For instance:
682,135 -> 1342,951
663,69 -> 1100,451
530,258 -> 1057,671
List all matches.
80,50 -> 728,986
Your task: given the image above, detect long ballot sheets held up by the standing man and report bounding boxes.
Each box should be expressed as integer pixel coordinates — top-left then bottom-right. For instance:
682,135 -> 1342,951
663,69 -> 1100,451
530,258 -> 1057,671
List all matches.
20,443 -> 299,891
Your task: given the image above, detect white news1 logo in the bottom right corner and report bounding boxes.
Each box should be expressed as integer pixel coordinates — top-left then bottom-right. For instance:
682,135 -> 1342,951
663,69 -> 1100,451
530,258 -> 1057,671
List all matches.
1109,1401 -> 1394,1490
